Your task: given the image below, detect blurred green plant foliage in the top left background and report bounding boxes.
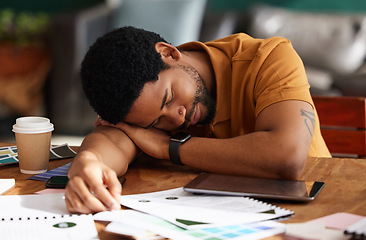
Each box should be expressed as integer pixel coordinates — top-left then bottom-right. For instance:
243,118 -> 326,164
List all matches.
0,9 -> 50,46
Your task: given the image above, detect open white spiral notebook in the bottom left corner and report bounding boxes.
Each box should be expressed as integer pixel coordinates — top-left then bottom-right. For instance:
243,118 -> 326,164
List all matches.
0,194 -> 98,240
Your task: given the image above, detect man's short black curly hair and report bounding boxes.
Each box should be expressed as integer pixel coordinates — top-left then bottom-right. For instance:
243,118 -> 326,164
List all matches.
81,26 -> 168,124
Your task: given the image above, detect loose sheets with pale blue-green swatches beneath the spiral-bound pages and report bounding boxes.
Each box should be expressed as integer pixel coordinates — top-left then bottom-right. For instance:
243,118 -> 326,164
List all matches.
94,210 -> 285,240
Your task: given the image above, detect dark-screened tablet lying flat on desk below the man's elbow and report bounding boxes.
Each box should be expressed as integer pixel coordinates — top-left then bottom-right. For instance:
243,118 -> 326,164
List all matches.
183,173 -> 324,201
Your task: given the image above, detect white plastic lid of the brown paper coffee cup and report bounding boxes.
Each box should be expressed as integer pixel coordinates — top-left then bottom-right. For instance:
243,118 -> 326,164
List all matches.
13,117 -> 54,134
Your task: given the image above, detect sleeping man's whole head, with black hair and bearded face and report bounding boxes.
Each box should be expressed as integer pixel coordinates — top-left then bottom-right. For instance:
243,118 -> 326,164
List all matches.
81,27 -> 215,130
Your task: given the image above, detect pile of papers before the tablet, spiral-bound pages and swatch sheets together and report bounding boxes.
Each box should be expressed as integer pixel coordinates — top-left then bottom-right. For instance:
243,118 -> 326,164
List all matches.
94,188 -> 293,240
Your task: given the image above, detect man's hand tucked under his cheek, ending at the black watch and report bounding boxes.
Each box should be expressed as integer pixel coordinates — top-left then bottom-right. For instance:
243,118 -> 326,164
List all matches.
100,120 -> 170,159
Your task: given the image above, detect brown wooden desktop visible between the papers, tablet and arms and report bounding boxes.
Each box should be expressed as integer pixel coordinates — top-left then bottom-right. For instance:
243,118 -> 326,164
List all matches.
0,143 -> 366,239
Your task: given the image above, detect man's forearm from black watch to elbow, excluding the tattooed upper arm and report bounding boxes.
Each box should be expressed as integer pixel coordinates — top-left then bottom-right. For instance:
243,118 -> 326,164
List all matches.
180,132 -> 309,179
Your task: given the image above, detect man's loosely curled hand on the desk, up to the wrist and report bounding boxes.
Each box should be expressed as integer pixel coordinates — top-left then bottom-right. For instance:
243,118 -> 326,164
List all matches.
65,152 -> 122,213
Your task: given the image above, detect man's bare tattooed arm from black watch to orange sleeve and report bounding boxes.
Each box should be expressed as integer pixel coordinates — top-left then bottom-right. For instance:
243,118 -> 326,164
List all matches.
180,101 -> 314,179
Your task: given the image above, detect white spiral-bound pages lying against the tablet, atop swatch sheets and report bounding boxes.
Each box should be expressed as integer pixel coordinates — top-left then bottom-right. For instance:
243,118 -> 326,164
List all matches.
121,188 -> 294,229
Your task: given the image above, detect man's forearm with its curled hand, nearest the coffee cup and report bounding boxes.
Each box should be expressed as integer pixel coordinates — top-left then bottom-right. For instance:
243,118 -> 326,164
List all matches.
65,126 -> 138,213
